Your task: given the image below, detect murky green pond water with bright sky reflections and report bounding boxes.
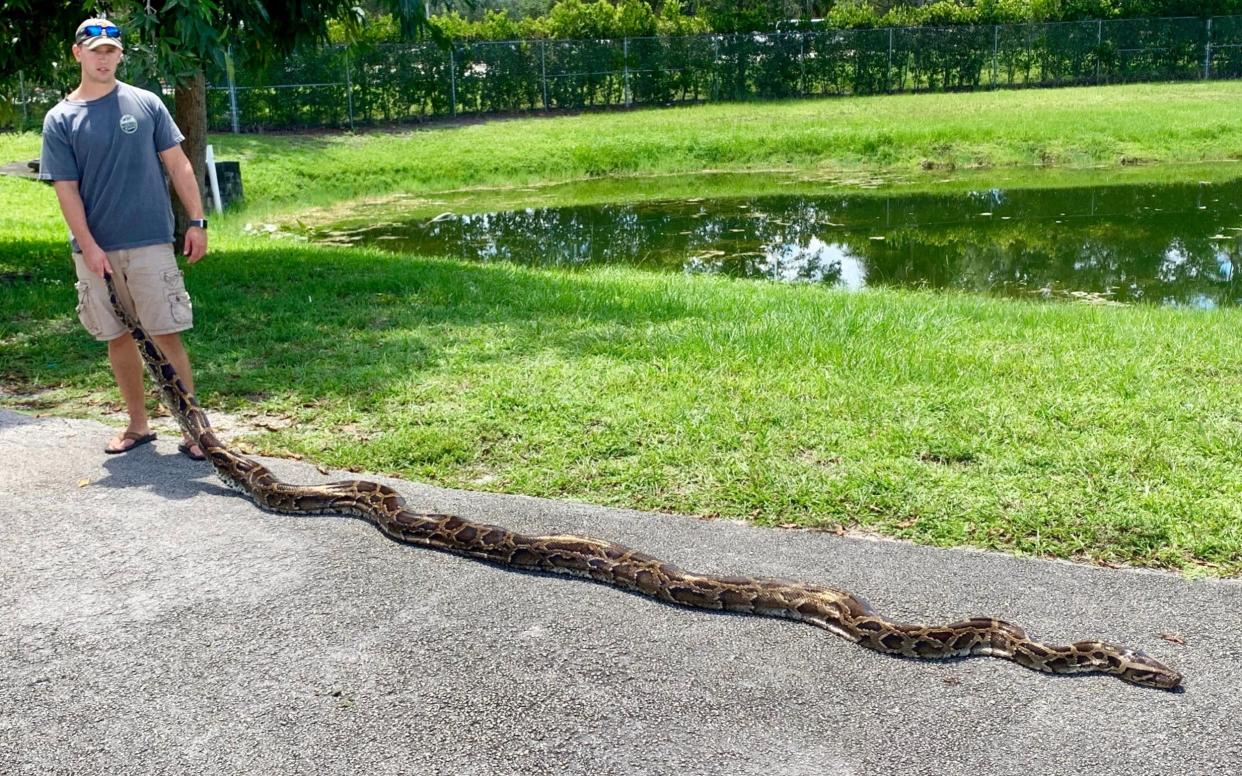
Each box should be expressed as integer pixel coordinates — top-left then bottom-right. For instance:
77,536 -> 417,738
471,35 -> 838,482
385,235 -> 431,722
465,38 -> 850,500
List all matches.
313,180 -> 1242,307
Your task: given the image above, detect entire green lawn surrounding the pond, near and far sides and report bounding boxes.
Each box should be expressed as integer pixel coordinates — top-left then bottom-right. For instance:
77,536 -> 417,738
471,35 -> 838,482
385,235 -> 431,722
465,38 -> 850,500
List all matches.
0,83 -> 1242,576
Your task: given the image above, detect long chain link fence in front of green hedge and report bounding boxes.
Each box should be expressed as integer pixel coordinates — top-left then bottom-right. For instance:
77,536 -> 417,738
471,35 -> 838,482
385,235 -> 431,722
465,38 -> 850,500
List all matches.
7,16 -> 1242,132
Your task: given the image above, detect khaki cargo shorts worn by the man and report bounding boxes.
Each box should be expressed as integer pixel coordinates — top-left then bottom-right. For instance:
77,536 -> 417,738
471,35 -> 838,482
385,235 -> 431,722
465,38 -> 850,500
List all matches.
73,242 -> 194,341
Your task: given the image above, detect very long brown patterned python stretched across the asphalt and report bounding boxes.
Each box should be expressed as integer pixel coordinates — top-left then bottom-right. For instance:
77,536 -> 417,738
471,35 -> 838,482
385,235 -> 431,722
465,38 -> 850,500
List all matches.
106,277 -> 1181,689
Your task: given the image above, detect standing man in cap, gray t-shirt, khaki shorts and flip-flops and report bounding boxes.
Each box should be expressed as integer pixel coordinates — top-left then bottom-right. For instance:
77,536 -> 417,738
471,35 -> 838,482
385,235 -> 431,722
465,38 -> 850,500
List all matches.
40,19 -> 207,461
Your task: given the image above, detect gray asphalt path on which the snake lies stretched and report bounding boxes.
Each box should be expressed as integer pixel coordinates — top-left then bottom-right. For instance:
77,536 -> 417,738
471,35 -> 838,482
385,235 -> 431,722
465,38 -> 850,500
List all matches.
0,411 -> 1242,776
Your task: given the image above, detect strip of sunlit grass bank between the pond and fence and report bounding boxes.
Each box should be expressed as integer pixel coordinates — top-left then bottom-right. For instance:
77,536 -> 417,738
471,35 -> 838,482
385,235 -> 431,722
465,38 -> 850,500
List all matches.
9,81 -> 1242,219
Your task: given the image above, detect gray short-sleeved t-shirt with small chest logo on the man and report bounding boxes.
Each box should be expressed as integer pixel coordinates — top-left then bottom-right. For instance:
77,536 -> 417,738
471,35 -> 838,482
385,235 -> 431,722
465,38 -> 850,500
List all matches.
39,81 -> 185,251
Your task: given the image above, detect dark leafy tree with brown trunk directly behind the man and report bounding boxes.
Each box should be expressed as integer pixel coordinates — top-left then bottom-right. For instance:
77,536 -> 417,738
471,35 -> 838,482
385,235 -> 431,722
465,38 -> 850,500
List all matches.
0,0 -> 430,233
